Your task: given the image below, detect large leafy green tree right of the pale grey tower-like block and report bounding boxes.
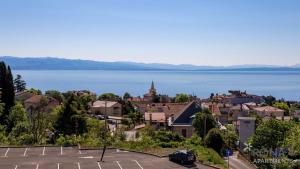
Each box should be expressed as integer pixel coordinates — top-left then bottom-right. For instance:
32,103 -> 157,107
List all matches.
251,119 -> 291,149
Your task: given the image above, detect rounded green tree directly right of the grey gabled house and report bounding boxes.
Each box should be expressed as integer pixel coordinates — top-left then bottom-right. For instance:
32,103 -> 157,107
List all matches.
193,109 -> 216,138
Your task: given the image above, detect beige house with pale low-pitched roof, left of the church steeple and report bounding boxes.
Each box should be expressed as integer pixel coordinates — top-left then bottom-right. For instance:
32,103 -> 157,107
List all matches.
91,100 -> 122,117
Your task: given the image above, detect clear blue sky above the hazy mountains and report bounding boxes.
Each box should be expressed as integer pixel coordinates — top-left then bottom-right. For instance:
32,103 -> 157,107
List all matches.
0,0 -> 300,66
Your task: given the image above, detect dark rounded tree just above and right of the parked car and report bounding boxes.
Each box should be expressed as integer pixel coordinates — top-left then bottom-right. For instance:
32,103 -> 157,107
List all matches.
204,128 -> 224,154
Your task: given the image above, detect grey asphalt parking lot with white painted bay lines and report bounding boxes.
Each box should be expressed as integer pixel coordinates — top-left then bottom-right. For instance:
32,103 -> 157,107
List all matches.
0,147 -> 213,169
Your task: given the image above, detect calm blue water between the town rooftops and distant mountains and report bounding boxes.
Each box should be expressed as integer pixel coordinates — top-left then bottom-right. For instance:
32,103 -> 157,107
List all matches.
13,70 -> 300,100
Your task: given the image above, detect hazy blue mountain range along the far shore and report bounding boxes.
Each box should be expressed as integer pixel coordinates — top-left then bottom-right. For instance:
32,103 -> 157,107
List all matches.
0,56 -> 300,71
